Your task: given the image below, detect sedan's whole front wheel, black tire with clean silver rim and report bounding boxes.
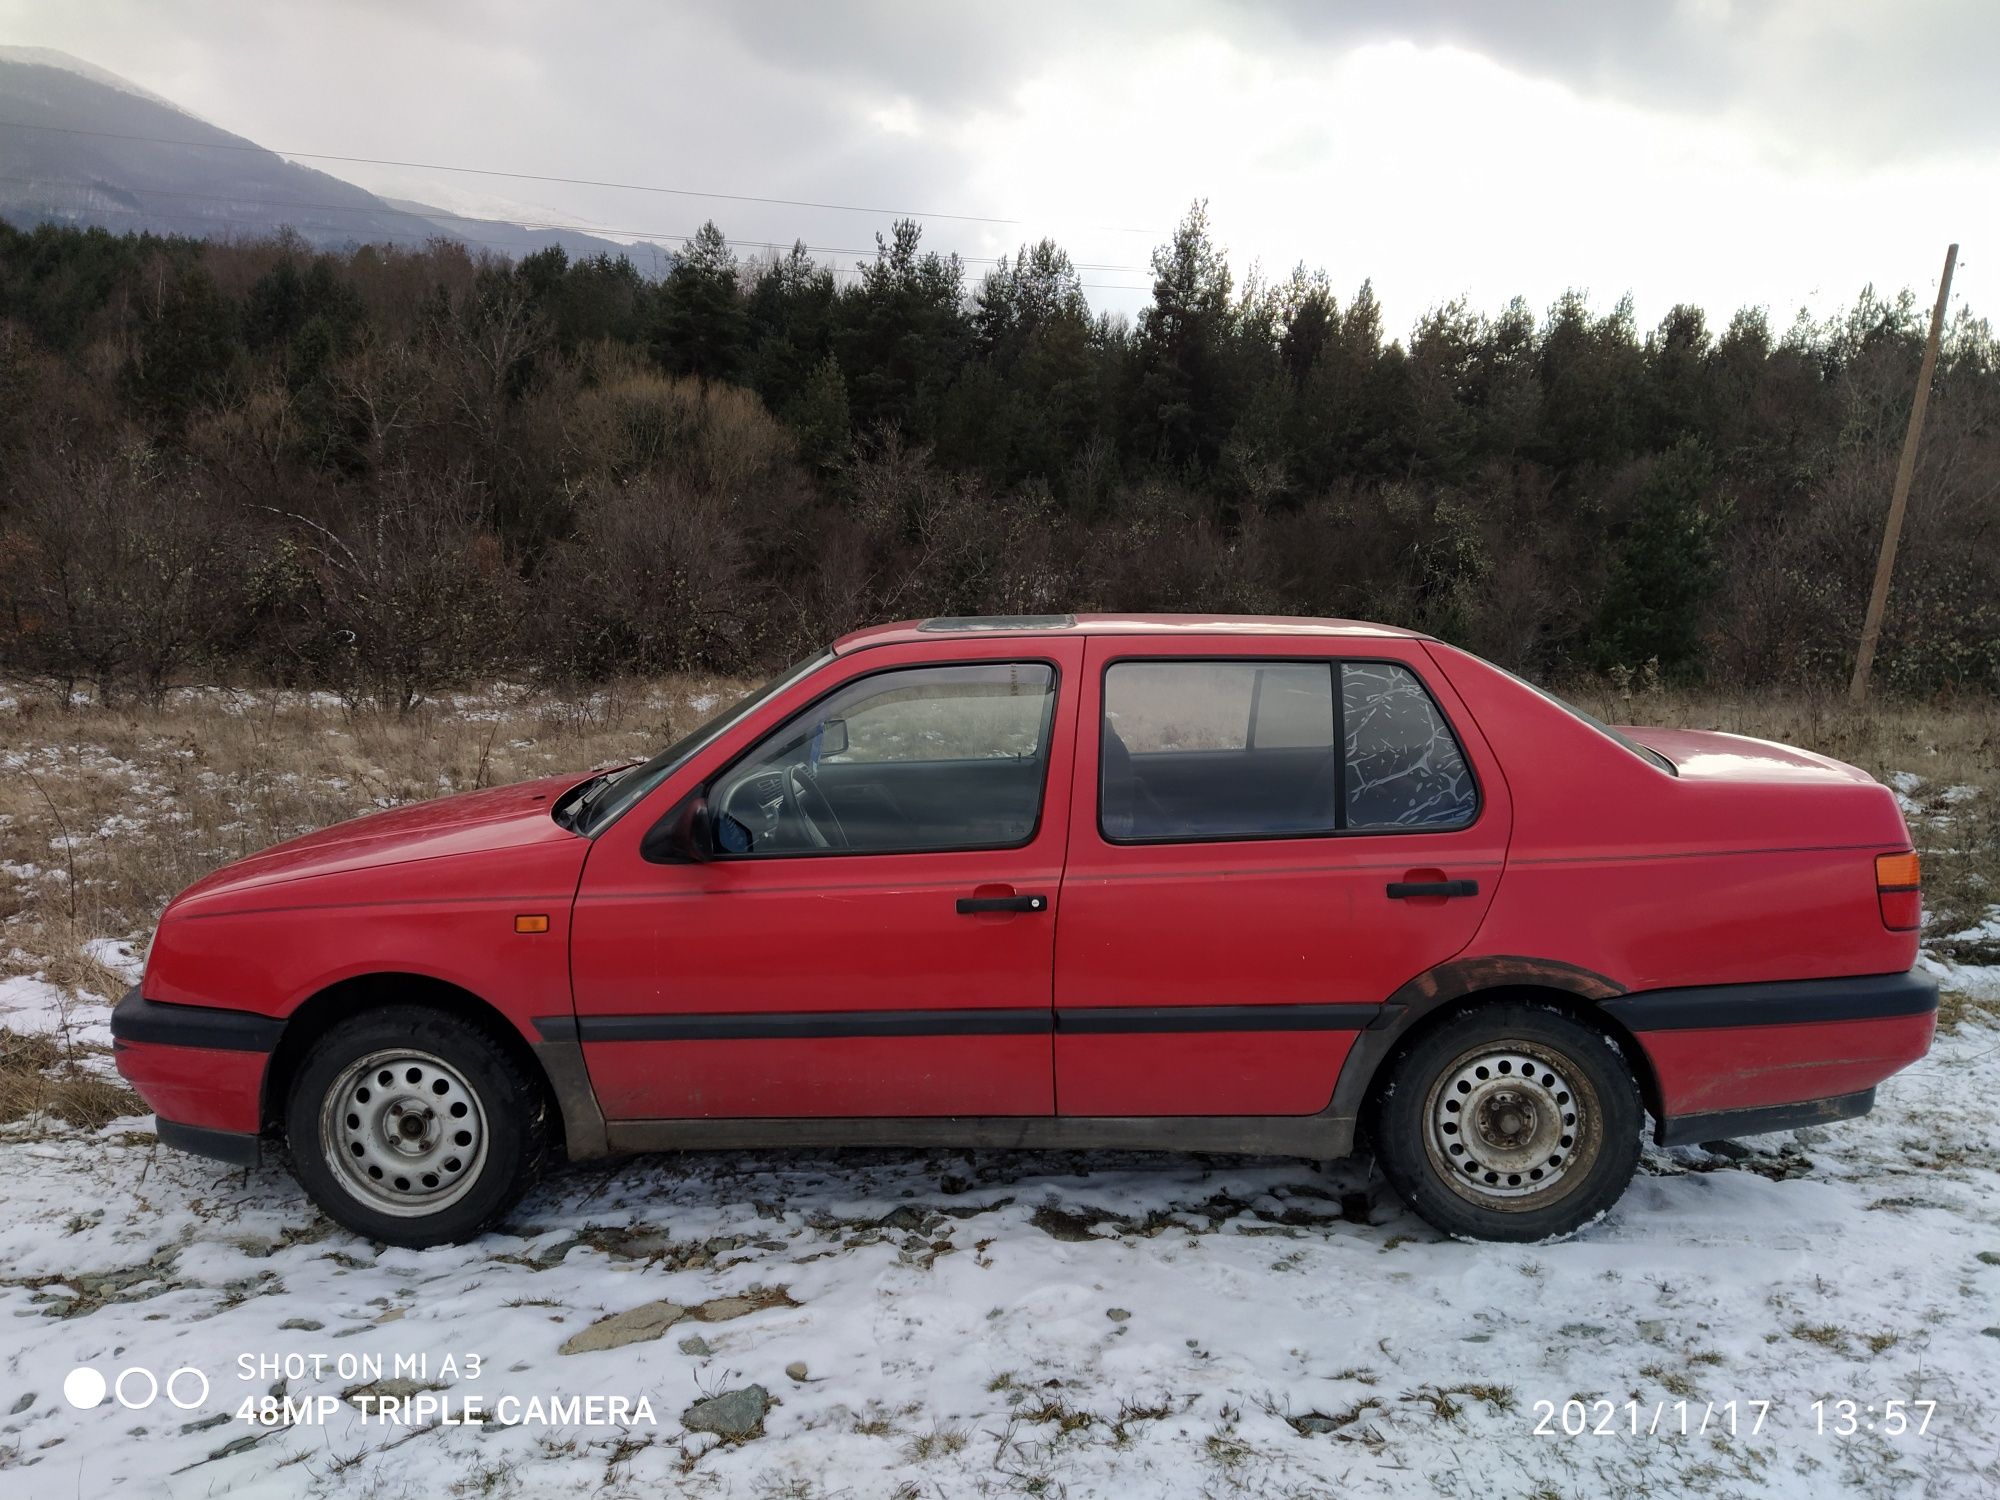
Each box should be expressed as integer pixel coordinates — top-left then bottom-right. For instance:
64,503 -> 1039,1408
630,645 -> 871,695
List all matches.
284,1006 -> 550,1250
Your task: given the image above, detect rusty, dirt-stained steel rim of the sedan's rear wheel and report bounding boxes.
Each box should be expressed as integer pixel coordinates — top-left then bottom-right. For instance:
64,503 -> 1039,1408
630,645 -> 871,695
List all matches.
1424,1038 -> 1604,1214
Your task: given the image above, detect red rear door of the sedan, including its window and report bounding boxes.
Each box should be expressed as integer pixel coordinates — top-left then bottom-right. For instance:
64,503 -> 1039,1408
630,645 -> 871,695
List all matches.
1056,636 -> 1508,1116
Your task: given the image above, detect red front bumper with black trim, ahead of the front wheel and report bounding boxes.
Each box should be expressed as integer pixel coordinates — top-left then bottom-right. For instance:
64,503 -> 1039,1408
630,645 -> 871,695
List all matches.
112,986 -> 284,1166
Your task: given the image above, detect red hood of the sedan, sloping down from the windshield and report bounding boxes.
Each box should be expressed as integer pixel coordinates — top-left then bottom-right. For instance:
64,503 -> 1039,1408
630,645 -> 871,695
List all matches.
174,774 -> 584,906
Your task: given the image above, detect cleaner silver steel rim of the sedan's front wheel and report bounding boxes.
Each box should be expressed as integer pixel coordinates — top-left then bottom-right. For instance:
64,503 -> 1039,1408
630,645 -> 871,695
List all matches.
320,1048 -> 490,1218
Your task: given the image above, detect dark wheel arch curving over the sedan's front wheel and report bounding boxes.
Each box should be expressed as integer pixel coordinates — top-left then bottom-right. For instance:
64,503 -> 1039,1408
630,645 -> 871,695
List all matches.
260,970 -> 602,1158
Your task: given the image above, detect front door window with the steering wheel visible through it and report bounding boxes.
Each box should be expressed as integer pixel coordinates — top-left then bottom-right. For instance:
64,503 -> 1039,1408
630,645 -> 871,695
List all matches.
708,662 -> 1056,856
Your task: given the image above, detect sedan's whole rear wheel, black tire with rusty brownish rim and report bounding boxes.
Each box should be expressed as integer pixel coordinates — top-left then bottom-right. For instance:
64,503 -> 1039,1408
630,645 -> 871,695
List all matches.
1370,1000 -> 1646,1244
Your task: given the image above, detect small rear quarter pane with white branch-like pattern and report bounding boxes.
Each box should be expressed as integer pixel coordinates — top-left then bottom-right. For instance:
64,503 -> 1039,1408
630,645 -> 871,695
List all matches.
1340,662 -> 1478,830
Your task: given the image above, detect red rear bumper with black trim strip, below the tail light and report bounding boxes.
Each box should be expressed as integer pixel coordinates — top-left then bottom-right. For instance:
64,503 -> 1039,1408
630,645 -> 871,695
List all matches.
1604,970 -> 1938,1146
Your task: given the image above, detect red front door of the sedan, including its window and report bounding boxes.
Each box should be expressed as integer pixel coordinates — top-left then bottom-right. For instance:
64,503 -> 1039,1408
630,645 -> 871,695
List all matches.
572,640 -> 1082,1120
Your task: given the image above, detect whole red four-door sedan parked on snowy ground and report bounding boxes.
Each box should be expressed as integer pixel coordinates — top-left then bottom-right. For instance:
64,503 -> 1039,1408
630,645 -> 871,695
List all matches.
112,616 -> 1938,1246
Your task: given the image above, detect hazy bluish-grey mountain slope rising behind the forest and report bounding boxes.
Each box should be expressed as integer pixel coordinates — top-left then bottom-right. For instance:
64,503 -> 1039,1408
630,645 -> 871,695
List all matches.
0,46 -> 640,270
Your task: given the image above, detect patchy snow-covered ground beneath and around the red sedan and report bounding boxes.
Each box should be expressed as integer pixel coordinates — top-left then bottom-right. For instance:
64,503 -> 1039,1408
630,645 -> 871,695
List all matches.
0,748 -> 2000,1500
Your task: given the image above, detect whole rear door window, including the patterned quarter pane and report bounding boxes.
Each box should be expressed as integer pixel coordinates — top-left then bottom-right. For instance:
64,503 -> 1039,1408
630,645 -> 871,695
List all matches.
1098,660 -> 1478,842
